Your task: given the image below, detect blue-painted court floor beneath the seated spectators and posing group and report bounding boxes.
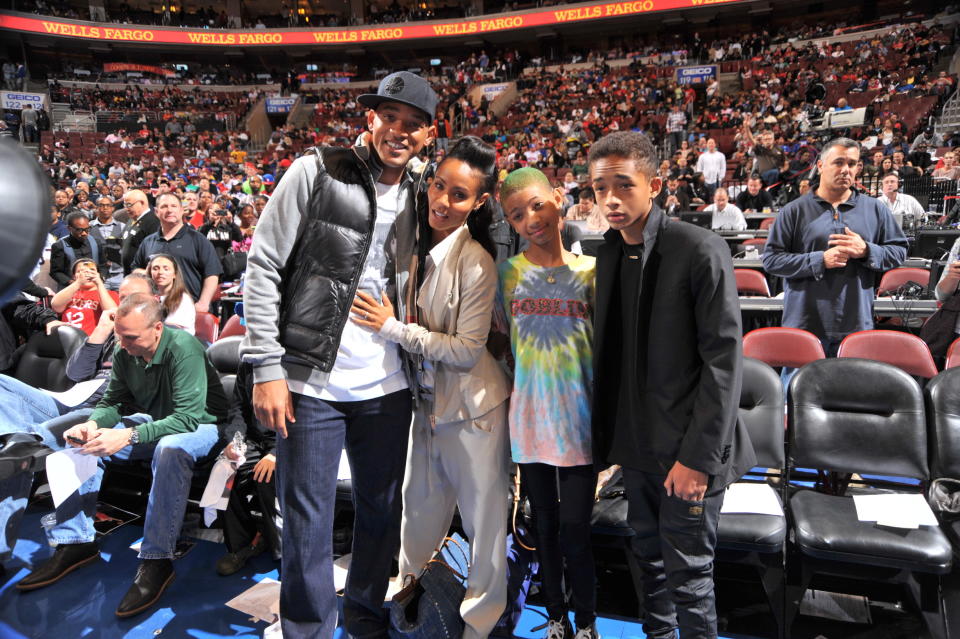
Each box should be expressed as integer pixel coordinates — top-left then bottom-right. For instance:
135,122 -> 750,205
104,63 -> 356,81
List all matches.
0,509 -> 772,639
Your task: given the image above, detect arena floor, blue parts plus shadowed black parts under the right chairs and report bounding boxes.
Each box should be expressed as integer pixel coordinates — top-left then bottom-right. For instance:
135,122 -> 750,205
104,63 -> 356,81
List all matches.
0,506 -> 926,639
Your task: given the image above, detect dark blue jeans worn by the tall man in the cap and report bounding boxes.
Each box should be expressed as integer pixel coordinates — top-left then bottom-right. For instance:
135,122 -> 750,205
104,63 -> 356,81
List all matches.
277,390 -> 412,639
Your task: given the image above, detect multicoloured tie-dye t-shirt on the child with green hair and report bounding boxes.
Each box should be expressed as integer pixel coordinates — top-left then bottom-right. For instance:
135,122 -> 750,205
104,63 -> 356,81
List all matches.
500,253 -> 596,466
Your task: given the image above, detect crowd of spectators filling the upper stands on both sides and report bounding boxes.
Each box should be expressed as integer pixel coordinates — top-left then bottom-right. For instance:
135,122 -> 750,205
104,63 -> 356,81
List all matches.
20,15 -> 957,235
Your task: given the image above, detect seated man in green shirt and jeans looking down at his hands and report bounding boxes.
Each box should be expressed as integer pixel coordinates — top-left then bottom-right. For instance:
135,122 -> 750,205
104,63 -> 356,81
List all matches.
17,293 -> 227,617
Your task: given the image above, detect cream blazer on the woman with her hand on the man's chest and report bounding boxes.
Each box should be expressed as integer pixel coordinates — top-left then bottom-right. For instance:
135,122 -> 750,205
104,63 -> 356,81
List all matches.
381,226 -> 510,427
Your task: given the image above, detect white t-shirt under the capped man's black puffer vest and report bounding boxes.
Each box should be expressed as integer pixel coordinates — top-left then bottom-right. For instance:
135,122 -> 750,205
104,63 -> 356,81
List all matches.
308,183 -> 407,402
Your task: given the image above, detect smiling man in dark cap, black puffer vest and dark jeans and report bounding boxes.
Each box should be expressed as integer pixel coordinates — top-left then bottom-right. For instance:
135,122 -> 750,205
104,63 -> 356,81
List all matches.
241,71 -> 437,639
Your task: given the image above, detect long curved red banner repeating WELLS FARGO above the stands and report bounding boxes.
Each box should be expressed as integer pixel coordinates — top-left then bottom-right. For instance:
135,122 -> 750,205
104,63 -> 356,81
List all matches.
0,0 -> 747,46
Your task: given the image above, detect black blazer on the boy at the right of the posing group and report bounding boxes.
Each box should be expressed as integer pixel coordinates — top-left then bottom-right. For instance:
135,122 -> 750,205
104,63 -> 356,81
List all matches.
593,205 -> 756,489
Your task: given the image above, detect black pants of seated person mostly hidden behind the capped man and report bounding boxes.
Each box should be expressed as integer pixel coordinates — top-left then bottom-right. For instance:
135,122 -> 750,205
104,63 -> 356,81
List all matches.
223,441 -> 280,556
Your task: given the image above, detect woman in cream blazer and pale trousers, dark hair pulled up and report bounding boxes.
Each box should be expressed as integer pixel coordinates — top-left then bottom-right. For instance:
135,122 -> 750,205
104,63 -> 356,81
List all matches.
353,137 -> 510,639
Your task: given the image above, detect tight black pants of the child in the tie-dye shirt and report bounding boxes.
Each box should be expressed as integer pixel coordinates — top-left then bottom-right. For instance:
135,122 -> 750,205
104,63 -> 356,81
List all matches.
520,464 -> 597,628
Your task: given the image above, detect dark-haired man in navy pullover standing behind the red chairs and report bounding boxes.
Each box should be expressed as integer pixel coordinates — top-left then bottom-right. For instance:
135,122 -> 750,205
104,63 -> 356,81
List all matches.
763,138 -> 908,357
